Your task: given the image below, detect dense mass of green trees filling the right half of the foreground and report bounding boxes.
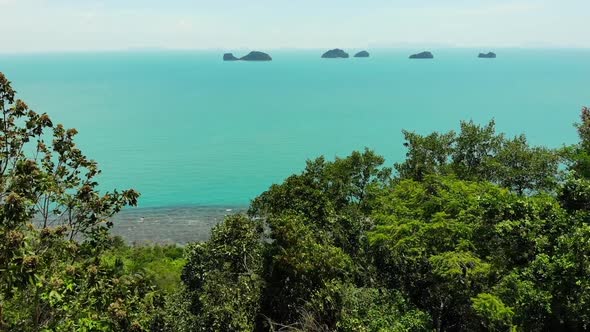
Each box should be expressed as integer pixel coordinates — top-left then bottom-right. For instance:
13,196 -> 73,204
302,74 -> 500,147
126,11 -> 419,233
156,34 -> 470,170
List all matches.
178,107 -> 590,331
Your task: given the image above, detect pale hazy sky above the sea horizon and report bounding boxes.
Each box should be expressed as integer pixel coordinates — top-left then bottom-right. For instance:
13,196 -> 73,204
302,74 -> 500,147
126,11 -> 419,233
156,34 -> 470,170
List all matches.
0,0 -> 590,52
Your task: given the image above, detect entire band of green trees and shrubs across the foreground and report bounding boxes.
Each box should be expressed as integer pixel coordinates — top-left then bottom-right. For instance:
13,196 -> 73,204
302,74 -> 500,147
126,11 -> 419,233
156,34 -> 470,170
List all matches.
0,73 -> 590,331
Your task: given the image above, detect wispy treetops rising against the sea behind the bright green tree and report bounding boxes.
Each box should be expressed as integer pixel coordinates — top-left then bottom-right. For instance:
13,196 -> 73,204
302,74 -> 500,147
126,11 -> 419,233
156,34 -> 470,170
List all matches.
395,121 -> 560,194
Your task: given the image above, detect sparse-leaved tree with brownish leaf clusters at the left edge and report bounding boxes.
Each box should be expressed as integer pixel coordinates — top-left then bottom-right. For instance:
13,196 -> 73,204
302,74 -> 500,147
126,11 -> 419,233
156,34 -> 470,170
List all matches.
0,73 -> 158,331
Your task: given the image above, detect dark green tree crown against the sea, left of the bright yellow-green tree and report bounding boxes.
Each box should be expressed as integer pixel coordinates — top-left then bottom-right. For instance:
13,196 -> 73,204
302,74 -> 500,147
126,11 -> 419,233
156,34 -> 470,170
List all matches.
249,149 -> 391,280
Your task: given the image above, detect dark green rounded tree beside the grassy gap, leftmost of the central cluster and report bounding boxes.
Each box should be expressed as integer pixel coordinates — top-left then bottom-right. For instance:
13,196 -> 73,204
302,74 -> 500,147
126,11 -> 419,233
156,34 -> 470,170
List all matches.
182,215 -> 263,332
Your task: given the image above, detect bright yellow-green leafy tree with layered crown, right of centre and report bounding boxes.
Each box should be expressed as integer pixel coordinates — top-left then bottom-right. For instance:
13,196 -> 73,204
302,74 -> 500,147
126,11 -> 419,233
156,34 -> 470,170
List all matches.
369,176 -> 508,331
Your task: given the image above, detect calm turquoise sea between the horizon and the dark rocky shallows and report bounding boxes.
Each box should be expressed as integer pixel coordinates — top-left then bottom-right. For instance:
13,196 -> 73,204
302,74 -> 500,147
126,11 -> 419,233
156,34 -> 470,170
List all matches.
0,49 -> 590,241
